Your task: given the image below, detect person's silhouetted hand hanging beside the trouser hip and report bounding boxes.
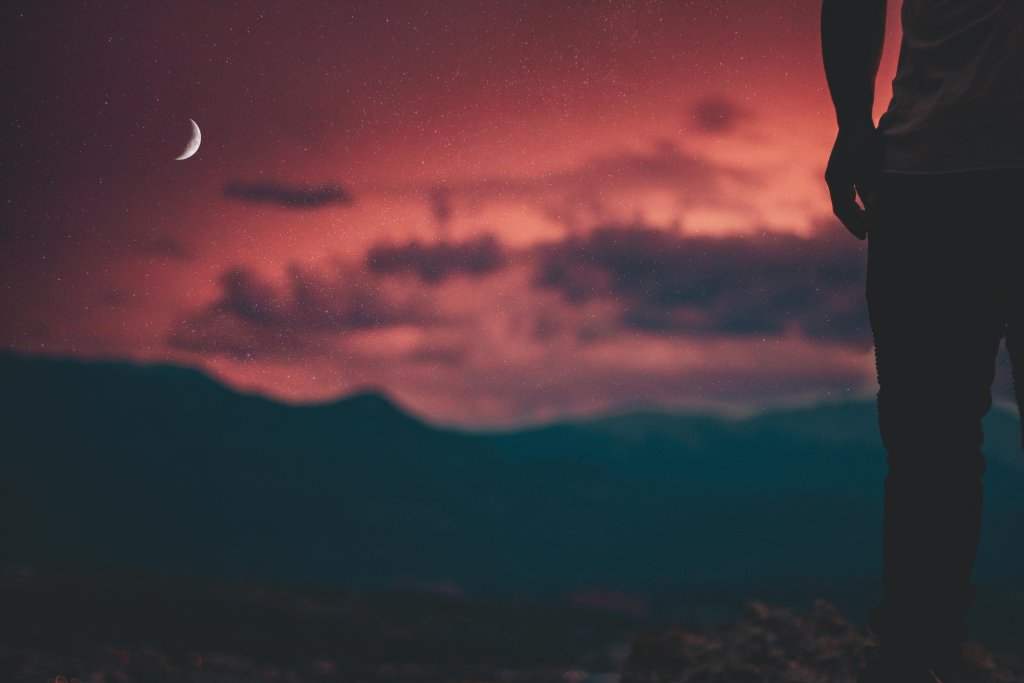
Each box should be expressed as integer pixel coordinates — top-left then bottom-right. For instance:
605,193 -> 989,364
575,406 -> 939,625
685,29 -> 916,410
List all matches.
825,125 -> 883,240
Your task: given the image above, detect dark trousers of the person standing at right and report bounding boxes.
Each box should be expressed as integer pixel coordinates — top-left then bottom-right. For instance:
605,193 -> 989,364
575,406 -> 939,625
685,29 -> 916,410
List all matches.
866,169 -> 1024,651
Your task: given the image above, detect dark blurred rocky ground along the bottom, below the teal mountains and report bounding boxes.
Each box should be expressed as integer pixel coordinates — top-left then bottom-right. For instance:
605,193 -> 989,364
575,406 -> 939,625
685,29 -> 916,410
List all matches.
0,571 -> 1024,683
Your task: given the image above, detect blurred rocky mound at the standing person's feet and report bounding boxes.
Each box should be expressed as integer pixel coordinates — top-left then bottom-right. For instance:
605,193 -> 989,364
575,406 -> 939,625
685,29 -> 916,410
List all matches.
621,600 -> 1024,683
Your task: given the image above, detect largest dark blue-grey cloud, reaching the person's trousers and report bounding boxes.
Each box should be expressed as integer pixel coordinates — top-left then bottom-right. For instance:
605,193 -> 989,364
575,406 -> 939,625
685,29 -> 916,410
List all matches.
532,220 -> 871,347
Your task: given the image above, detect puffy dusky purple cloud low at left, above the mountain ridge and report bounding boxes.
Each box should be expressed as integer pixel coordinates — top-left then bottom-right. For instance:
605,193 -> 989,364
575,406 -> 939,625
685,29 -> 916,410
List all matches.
168,259 -> 442,358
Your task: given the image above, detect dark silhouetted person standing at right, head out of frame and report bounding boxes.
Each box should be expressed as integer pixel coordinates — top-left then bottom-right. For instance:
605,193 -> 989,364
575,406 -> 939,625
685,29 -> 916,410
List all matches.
821,0 -> 1024,683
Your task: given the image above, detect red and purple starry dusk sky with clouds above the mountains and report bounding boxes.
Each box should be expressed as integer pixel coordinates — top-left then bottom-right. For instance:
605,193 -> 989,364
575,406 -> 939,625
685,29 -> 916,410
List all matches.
6,0 -> 1015,426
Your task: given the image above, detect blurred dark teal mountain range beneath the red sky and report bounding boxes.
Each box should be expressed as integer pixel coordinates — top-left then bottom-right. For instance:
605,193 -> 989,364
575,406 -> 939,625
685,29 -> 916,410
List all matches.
0,355 -> 1024,600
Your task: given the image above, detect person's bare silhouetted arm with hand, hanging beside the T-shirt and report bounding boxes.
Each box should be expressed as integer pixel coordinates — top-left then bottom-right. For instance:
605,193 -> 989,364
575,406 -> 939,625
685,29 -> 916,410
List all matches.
821,0 -> 886,240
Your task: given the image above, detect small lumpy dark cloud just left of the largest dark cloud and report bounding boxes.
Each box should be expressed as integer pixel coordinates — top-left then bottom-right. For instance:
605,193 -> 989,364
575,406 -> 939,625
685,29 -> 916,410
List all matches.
366,232 -> 507,284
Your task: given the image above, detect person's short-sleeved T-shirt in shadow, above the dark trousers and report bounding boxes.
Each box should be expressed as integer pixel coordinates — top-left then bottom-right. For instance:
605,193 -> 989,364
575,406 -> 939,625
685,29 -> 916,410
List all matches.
879,0 -> 1024,172
